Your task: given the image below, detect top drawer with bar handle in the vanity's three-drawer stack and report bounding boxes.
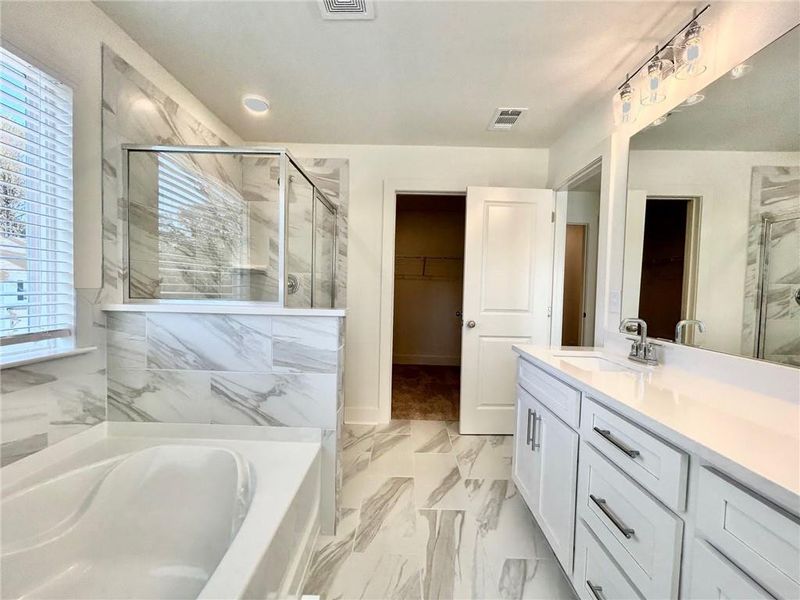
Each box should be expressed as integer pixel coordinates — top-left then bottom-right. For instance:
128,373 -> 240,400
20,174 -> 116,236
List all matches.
581,397 -> 689,512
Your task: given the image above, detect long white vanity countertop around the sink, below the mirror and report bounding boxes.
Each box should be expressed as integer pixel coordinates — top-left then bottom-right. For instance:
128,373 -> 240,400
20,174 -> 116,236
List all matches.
514,345 -> 800,513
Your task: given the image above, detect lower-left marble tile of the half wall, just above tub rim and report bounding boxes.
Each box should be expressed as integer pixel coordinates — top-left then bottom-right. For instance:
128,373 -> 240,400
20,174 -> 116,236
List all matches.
108,369 -> 211,423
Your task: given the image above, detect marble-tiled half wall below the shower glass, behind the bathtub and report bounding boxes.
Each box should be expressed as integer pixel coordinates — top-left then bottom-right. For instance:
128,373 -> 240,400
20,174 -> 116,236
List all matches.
107,312 -> 344,531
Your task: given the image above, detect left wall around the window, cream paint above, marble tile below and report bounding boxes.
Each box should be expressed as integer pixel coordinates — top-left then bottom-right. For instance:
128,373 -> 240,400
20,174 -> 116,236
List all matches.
0,2 -> 238,464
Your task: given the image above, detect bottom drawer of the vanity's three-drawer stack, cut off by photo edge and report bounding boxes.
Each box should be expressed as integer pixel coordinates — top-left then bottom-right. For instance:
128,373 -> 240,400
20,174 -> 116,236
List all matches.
573,520 -> 642,600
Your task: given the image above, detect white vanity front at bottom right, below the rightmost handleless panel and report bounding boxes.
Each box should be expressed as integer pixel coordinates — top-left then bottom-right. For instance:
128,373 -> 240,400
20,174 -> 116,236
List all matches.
688,539 -> 772,600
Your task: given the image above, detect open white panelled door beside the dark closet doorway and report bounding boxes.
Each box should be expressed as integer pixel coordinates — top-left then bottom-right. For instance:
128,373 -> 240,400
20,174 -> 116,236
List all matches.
460,187 -> 553,434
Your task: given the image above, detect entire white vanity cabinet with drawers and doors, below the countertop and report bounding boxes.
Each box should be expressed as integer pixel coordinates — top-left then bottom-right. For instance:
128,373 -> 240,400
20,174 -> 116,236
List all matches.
513,357 -> 800,600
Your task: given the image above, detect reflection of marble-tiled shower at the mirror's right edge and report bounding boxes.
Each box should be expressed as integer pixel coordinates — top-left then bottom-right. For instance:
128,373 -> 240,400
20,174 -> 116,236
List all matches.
742,166 -> 800,366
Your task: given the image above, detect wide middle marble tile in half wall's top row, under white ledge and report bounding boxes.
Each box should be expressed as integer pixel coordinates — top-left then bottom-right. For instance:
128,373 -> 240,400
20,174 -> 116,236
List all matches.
147,313 -> 271,372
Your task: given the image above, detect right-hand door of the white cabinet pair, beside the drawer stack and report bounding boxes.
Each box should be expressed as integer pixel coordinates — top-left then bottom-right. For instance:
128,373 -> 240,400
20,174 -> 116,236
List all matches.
532,400 -> 578,573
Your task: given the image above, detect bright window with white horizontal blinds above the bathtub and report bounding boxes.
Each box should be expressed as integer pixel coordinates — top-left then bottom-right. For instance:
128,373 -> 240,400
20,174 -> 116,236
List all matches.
0,48 -> 75,359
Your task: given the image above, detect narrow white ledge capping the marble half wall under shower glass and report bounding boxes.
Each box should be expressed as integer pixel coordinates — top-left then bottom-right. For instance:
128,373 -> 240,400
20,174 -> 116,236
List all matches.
100,302 -> 346,317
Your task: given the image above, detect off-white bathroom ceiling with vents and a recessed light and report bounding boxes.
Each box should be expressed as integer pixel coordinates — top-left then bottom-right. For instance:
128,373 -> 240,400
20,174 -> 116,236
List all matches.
95,0 -> 696,147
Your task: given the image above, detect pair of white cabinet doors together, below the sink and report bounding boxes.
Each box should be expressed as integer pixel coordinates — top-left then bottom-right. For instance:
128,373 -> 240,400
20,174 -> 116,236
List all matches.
513,386 -> 578,572
